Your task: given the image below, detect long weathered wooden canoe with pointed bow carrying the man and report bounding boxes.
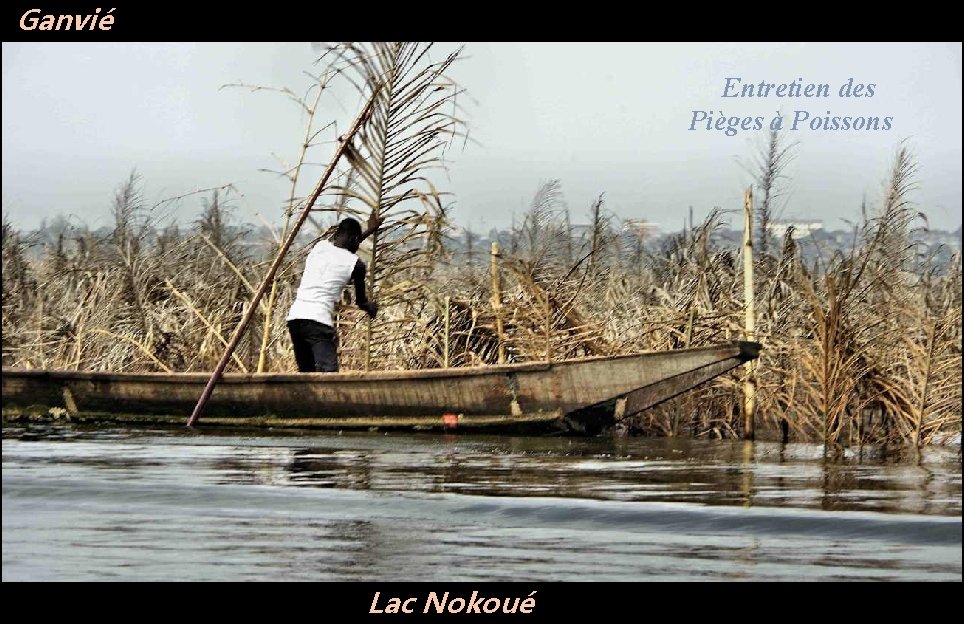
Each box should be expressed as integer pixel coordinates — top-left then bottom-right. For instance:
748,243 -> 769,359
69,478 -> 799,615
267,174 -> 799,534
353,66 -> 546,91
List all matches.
2,342 -> 760,433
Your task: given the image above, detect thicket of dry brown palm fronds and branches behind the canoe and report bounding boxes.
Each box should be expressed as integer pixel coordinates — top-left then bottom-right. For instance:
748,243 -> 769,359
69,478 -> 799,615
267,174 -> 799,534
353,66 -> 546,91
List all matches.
2,46 -> 962,445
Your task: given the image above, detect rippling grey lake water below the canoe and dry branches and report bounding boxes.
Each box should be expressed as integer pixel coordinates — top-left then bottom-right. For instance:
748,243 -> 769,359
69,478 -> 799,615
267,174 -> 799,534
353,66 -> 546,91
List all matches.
3,426 -> 961,581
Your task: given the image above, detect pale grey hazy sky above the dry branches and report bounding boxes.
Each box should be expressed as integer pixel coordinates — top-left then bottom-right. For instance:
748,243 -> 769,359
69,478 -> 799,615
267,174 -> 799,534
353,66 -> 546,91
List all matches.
2,43 -> 962,231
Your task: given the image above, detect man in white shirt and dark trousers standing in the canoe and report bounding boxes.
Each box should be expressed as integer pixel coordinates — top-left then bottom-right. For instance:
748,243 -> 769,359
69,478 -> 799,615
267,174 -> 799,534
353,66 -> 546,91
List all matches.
288,215 -> 384,373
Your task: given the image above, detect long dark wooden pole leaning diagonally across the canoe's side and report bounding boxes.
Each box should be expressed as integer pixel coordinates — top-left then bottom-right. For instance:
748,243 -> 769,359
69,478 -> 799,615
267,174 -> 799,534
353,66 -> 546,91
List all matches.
187,90 -> 378,427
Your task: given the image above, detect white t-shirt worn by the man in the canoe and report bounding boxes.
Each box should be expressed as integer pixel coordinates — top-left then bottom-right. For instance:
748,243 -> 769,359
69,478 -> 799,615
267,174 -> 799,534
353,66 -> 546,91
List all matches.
287,241 -> 358,327
